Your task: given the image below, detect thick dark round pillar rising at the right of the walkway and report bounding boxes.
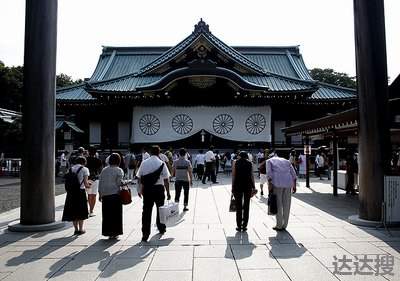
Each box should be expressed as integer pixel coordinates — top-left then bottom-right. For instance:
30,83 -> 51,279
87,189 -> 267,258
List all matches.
354,0 -> 390,221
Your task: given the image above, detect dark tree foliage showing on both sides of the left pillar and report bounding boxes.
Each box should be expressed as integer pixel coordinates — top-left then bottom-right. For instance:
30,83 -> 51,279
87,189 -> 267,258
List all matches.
0,60 -> 82,111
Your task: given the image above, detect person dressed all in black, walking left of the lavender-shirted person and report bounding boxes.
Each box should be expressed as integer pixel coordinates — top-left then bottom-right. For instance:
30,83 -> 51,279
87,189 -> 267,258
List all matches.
232,151 -> 256,231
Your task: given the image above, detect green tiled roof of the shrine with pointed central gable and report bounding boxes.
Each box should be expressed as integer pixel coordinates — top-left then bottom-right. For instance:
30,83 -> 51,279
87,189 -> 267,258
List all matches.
57,20 -> 356,102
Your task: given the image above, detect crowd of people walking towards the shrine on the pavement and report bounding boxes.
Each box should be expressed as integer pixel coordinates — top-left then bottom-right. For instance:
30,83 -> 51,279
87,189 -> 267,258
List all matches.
61,145 -> 296,241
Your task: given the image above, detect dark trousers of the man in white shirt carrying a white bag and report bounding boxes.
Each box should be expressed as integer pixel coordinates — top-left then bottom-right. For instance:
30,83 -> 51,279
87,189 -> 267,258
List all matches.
142,185 -> 166,238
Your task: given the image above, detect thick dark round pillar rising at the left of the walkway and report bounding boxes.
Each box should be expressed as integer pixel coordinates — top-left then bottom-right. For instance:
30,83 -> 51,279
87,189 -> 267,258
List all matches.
20,0 -> 57,225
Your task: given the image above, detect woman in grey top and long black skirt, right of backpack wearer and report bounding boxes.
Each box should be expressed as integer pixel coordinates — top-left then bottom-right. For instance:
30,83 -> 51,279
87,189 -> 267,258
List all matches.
99,153 -> 124,239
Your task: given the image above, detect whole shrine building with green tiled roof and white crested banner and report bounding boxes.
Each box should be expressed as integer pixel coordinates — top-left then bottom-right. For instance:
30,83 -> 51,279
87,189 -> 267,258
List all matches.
56,20 -> 357,149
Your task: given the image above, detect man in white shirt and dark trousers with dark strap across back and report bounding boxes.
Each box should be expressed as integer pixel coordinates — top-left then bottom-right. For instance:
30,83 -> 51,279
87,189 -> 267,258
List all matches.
136,145 -> 171,241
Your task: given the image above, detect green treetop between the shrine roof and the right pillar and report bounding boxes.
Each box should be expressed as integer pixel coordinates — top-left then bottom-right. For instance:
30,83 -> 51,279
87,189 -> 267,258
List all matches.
310,68 -> 357,89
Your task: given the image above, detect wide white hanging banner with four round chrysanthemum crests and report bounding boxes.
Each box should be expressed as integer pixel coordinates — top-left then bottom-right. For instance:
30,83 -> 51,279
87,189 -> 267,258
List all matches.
131,106 -> 271,143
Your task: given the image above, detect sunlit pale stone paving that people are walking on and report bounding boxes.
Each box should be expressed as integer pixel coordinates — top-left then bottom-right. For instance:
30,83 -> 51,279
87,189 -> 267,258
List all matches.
0,174 -> 400,281
